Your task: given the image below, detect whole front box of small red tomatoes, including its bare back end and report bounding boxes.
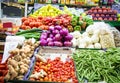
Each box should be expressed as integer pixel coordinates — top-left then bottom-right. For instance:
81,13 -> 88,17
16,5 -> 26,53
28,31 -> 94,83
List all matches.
29,47 -> 78,83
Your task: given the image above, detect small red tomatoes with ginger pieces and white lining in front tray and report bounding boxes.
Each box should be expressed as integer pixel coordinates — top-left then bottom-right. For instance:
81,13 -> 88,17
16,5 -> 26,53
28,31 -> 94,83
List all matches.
30,54 -> 78,83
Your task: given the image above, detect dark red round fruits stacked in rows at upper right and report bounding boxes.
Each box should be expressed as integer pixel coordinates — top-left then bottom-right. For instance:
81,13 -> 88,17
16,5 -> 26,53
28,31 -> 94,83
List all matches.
88,7 -> 118,21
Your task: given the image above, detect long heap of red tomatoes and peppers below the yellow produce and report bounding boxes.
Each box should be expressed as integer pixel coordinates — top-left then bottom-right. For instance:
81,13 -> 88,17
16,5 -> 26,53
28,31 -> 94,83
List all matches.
21,15 -> 72,30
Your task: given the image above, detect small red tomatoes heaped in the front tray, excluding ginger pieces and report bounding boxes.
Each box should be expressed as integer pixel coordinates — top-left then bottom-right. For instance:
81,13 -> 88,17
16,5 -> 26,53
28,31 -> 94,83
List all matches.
30,57 -> 78,83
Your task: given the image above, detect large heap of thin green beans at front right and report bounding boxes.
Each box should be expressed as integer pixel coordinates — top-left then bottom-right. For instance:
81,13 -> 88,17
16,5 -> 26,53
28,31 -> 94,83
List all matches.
73,48 -> 120,83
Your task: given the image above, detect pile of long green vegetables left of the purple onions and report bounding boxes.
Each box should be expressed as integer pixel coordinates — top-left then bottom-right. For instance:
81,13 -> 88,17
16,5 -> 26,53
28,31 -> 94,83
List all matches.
16,28 -> 42,41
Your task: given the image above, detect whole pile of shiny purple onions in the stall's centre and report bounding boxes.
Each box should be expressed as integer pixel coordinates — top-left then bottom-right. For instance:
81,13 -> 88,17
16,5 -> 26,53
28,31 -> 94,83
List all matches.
40,25 -> 73,47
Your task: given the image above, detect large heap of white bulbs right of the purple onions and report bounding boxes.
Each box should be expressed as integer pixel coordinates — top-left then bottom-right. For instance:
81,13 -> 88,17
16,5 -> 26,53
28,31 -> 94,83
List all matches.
71,22 -> 115,48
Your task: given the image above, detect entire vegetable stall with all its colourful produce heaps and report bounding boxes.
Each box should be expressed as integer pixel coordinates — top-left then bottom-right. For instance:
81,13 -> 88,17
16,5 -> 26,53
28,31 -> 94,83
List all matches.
0,4 -> 120,83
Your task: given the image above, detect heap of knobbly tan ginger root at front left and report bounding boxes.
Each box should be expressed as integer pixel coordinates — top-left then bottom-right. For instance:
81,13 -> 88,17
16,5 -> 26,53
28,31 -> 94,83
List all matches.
5,39 -> 39,80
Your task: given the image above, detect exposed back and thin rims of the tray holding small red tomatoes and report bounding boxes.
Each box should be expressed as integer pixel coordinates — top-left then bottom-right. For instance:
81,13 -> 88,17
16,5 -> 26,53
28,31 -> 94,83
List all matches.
29,47 -> 79,83
